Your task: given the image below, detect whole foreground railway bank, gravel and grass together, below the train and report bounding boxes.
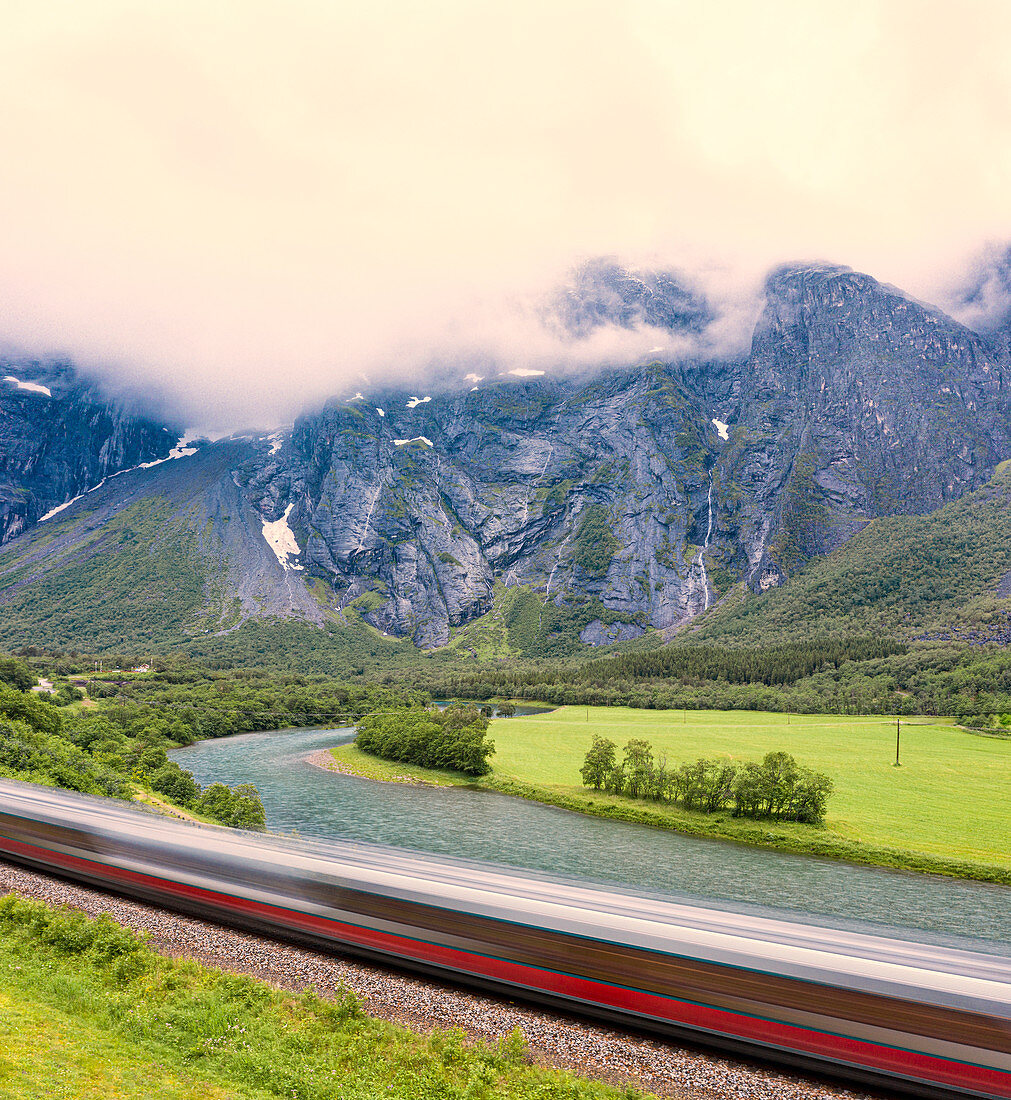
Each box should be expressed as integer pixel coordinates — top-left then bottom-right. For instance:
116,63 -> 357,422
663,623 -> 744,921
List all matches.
0,862 -> 875,1100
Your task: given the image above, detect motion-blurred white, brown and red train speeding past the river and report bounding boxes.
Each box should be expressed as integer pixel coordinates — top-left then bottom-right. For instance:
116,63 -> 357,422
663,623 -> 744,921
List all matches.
0,781 -> 1011,1097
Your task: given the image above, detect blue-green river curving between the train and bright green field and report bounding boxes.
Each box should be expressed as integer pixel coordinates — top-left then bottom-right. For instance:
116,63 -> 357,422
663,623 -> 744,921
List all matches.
173,729 -> 1011,955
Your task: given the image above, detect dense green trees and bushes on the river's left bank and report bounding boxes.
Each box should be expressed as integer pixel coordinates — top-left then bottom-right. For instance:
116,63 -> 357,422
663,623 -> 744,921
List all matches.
0,648 -> 427,828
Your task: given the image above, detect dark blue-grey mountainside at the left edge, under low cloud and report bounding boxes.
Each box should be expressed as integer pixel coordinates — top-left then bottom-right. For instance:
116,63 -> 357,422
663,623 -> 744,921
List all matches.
0,360 -> 178,543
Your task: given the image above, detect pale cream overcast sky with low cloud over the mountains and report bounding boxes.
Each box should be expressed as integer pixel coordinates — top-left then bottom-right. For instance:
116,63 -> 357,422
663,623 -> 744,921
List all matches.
0,0 -> 1011,426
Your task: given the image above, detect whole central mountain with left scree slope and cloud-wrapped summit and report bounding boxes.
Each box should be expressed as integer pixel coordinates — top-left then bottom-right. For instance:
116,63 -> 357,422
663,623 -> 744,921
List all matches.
0,262 -> 1011,656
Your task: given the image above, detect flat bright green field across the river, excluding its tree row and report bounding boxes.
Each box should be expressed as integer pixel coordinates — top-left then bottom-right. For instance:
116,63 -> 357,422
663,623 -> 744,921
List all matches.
334,706 -> 1011,884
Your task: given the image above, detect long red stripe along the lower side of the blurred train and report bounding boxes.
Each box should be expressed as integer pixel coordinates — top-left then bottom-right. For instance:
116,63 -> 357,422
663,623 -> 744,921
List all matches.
0,837 -> 1011,1097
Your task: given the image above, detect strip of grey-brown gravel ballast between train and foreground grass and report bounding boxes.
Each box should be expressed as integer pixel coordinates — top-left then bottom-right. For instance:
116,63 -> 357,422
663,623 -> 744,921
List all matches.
0,862 -> 880,1100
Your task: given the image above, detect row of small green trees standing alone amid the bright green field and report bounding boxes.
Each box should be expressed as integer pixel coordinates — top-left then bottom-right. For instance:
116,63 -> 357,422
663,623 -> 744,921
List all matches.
581,737 -> 833,823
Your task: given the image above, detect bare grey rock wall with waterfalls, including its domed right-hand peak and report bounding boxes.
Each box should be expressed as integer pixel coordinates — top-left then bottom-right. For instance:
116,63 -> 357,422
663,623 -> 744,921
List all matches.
233,266 -> 1011,647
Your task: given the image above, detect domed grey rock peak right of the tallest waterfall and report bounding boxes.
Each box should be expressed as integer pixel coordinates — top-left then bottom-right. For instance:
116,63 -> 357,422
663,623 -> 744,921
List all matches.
722,265 -> 1011,585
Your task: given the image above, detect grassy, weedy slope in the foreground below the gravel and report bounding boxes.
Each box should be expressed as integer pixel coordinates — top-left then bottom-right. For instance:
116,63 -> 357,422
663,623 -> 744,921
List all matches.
0,897 -> 641,1100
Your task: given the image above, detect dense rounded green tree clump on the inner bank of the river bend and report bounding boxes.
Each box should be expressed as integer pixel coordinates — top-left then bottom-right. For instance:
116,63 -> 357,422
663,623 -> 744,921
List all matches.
355,704 -> 495,776
